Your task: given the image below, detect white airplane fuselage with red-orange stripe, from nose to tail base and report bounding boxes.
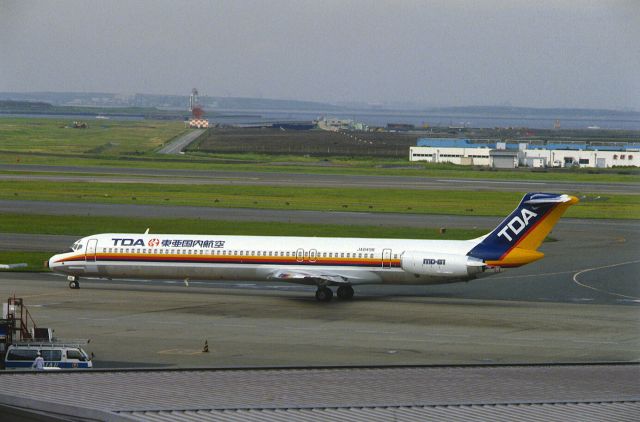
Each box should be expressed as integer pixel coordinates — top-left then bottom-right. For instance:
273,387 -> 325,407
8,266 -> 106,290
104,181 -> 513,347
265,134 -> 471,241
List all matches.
49,233 -> 484,284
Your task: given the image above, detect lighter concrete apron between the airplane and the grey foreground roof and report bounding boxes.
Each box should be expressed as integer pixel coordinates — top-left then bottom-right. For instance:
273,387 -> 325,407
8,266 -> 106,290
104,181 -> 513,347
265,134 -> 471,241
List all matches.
0,273 -> 640,368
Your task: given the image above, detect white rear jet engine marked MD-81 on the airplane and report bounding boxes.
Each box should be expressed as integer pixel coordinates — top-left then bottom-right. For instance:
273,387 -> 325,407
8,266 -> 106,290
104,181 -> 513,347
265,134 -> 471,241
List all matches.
400,251 -> 486,278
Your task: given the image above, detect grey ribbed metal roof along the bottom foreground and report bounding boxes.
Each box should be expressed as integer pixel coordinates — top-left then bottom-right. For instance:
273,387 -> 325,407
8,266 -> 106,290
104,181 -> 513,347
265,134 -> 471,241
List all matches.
0,364 -> 640,421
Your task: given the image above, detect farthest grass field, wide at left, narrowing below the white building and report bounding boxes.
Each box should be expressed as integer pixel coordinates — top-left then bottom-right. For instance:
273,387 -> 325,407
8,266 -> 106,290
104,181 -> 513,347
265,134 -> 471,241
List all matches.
0,118 -> 640,183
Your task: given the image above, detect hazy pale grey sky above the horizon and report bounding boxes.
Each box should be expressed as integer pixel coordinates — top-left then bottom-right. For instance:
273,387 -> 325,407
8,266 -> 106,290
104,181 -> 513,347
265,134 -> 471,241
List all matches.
0,0 -> 640,110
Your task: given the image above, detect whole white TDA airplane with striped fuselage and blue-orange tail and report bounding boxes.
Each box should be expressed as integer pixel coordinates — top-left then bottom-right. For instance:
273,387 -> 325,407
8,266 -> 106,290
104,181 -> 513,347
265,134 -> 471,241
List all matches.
45,193 -> 578,301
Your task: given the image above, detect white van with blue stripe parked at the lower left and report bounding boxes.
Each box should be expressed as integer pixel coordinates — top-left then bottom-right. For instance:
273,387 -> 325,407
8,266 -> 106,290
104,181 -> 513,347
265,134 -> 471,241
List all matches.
4,343 -> 93,369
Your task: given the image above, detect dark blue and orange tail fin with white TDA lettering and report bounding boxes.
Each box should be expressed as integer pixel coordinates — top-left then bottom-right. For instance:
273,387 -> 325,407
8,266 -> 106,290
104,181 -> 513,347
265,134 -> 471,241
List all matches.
467,193 -> 578,267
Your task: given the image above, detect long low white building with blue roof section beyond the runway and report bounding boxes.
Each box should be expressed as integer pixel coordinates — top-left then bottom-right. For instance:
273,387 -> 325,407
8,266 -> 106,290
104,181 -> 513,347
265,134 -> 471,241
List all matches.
409,139 -> 640,168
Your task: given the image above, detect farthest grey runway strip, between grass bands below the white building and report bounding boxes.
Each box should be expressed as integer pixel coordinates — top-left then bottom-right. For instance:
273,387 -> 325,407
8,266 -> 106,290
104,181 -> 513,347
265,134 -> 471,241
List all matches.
0,164 -> 640,195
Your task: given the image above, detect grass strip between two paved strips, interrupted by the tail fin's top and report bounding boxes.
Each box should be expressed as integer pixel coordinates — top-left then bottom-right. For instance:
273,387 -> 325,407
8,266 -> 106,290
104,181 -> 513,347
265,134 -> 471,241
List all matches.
0,181 -> 640,219
